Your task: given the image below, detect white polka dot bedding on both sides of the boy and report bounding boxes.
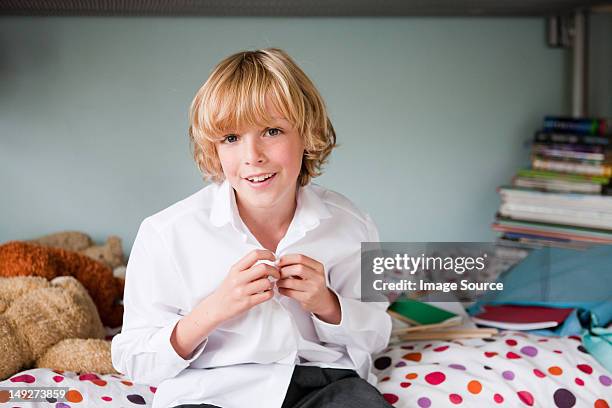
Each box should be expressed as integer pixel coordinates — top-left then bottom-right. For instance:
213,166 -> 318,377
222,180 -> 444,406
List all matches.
0,331 -> 612,408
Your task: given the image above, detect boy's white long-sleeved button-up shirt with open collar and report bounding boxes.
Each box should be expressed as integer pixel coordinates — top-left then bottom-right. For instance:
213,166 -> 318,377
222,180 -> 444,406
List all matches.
112,181 -> 391,408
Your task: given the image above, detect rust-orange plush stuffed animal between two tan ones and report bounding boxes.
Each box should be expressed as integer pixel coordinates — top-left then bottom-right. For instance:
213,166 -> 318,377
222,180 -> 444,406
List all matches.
0,241 -> 124,327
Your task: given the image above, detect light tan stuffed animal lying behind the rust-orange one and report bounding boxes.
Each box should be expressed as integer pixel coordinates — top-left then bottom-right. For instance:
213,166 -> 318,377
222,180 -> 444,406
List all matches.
27,231 -> 125,269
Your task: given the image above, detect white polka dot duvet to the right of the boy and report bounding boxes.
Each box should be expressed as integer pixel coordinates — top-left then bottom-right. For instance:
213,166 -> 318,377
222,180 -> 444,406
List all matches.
373,331 -> 612,408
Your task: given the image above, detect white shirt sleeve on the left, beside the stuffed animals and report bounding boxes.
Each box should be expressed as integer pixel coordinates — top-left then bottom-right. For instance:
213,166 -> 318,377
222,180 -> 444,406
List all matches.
111,220 -> 208,385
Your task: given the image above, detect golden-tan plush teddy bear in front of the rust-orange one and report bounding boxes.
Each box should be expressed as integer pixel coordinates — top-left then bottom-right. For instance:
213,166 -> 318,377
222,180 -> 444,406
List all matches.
0,276 -> 116,380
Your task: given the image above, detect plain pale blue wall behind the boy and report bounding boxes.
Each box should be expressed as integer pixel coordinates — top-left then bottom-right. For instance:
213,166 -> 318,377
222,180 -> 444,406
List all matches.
0,17 -> 569,255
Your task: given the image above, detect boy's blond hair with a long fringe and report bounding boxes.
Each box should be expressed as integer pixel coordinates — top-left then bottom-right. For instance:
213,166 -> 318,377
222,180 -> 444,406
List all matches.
189,48 -> 336,186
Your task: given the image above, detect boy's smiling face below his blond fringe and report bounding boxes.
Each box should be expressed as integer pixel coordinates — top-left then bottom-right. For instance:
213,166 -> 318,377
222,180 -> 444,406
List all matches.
216,100 -> 304,214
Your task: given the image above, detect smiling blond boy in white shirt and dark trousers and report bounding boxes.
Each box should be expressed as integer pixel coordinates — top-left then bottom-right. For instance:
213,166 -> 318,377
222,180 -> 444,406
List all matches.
112,49 -> 391,408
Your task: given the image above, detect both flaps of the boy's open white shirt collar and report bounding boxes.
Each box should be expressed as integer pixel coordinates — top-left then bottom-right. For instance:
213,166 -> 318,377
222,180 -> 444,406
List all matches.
210,180 -> 331,232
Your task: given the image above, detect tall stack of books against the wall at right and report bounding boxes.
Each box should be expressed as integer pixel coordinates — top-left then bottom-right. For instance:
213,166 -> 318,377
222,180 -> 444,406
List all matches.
492,116 -> 612,247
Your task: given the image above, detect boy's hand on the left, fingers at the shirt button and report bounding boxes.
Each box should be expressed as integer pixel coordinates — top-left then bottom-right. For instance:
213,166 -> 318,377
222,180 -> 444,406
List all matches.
213,249 -> 280,322
